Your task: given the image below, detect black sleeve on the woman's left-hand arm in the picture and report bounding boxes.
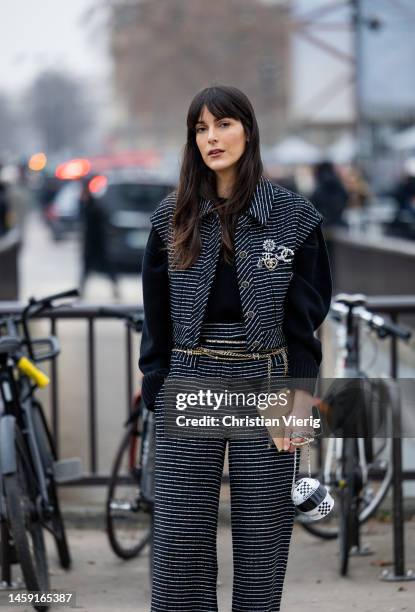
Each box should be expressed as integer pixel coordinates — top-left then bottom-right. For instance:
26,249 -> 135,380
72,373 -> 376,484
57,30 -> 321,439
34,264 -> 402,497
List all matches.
138,228 -> 173,410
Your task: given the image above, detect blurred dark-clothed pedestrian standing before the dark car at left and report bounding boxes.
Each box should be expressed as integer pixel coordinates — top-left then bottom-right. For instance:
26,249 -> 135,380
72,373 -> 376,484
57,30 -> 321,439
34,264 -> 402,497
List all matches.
79,177 -> 119,300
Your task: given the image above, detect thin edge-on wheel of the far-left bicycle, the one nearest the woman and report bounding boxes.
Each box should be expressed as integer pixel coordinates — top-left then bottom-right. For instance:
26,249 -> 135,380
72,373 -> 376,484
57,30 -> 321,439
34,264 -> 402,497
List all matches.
32,400 -> 72,569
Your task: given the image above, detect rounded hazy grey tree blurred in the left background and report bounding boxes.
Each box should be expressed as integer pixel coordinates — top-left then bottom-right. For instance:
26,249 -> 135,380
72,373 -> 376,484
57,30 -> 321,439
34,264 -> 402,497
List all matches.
29,70 -> 91,153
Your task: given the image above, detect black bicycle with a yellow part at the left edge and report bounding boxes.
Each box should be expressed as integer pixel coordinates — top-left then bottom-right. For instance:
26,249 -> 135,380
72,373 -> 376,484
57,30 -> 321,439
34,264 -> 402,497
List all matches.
0,290 -> 80,610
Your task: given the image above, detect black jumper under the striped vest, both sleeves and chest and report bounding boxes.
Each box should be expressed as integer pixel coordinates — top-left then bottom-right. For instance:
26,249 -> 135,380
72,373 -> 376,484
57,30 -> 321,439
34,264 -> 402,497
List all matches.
139,213 -> 332,409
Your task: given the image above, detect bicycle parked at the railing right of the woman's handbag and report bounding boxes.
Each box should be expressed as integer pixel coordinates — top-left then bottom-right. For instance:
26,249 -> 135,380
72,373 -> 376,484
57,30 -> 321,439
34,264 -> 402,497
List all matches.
298,294 -> 411,576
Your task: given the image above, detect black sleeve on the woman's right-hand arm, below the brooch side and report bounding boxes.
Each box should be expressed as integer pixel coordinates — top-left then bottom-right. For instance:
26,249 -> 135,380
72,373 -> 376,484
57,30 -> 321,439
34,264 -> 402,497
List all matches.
284,224 -> 332,391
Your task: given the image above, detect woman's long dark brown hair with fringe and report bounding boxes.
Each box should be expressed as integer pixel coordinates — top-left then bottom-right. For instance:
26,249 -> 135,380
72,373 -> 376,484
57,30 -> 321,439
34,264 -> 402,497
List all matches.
170,85 -> 263,269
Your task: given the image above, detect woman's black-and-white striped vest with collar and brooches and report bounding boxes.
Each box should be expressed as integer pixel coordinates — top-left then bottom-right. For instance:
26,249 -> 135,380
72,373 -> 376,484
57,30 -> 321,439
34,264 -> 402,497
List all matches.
150,177 -> 323,352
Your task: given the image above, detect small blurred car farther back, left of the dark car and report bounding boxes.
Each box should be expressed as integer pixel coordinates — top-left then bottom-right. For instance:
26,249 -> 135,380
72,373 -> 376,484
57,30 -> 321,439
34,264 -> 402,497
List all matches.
46,181 -> 82,240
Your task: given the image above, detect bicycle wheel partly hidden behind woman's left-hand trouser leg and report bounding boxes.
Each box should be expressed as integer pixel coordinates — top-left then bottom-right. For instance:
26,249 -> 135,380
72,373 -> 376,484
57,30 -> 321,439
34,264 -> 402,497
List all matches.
106,410 -> 152,559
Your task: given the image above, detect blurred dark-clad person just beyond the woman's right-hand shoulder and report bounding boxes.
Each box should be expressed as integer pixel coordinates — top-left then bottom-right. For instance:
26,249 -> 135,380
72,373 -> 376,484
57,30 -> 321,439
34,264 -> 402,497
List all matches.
310,161 -> 349,228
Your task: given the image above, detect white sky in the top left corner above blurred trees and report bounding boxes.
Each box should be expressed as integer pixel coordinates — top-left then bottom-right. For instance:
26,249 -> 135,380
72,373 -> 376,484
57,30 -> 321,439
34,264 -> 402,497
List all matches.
0,0 -> 109,93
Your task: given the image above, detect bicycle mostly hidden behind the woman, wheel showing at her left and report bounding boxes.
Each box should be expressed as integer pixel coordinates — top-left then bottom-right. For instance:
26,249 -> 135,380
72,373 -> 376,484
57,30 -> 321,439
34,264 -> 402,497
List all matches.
101,308 -> 155,575
